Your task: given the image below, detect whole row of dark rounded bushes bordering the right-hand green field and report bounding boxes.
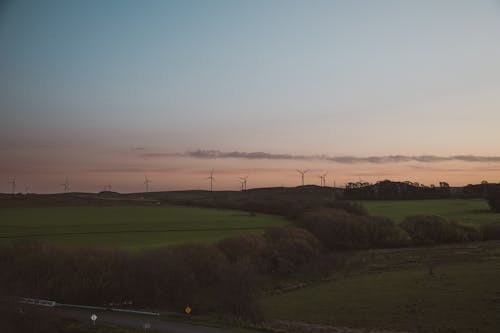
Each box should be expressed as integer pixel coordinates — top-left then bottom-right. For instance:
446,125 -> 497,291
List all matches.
297,208 -> 492,251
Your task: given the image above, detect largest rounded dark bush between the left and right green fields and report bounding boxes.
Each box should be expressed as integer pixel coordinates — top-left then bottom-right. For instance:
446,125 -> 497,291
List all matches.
299,208 -> 408,250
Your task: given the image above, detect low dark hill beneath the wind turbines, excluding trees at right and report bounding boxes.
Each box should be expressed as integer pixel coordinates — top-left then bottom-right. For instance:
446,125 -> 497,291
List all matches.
0,185 -> 343,216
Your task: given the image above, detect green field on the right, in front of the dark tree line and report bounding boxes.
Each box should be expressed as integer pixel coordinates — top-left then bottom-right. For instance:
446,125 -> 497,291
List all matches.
358,199 -> 500,226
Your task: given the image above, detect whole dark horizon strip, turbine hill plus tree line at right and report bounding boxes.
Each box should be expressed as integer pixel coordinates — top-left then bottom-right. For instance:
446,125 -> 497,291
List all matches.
0,180 -> 500,210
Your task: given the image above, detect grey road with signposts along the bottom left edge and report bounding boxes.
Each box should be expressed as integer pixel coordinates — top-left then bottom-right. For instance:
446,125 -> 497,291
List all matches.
54,308 -> 237,333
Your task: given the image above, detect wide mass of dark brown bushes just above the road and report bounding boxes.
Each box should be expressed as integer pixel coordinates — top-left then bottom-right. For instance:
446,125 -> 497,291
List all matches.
0,240 -> 260,320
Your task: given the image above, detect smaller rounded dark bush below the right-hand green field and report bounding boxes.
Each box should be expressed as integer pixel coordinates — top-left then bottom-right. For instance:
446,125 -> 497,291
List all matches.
400,215 -> 481,245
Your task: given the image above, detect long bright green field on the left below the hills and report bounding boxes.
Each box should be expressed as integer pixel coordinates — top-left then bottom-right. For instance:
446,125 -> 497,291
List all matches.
0,206 -> 287,250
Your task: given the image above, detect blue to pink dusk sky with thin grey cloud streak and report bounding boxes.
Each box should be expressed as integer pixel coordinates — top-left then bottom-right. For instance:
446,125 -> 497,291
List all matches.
0,0 -> 500,193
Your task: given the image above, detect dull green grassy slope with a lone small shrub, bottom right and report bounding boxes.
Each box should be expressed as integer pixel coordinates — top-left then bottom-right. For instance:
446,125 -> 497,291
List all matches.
262,242 -> 500,333
